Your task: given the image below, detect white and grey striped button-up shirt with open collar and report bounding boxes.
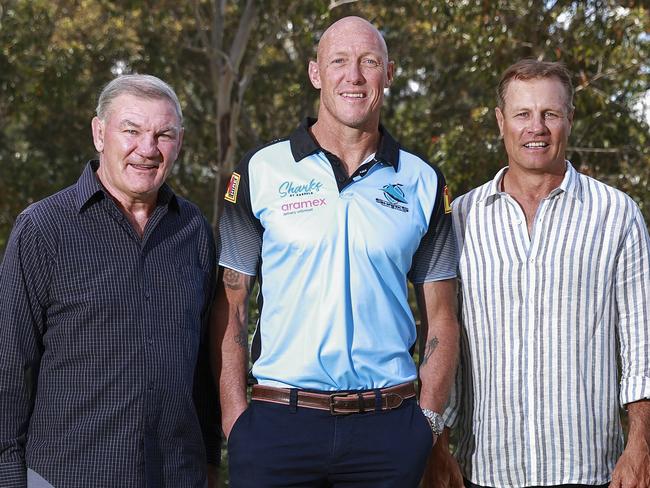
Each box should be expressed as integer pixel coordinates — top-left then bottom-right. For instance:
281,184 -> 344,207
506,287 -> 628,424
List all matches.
445,162 -> 650,487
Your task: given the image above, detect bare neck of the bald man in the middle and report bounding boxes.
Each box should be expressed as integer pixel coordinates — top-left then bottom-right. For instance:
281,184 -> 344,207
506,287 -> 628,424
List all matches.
310,118 -> 380,176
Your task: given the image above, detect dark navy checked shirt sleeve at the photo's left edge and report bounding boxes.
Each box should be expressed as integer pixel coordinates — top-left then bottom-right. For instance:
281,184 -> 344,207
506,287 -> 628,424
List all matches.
0,213 -> 50,487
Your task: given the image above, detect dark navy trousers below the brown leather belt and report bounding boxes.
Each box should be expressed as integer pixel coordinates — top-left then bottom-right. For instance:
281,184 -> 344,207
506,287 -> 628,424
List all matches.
228,398 -> 433,488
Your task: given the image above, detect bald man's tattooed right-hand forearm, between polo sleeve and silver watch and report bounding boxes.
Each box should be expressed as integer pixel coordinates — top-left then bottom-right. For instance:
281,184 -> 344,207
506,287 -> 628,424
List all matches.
416,280 -> 459,412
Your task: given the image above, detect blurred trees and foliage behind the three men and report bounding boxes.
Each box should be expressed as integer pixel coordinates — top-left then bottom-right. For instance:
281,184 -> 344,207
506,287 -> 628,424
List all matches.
0,0 -> 650,482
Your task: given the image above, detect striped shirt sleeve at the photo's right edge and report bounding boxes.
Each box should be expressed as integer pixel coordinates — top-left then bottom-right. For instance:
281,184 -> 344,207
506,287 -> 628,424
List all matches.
616,207 -> 650,405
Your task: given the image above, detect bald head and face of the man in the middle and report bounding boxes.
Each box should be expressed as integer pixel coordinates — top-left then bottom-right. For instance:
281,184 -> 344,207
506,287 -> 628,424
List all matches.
309,18 -> 393,130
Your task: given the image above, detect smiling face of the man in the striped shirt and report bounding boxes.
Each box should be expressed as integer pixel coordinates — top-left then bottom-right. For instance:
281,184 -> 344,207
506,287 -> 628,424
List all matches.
496,78 -> 573,173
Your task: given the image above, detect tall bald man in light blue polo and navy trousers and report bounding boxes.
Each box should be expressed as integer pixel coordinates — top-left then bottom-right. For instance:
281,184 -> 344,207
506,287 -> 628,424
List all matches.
213,17 -> 458,488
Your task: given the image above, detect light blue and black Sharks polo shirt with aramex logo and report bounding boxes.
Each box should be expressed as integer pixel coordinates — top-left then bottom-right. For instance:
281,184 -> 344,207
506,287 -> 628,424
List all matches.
219,120 -> 457,391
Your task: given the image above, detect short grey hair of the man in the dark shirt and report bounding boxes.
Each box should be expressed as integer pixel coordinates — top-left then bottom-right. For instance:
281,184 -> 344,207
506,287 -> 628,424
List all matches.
95,74 -> 183,125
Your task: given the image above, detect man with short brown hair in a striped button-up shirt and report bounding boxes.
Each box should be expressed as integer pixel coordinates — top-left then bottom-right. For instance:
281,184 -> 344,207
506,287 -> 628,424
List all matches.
427,59 -> 650,488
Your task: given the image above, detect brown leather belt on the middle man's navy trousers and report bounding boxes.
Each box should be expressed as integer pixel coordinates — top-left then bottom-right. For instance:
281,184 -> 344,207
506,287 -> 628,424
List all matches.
252,383 -> 415,415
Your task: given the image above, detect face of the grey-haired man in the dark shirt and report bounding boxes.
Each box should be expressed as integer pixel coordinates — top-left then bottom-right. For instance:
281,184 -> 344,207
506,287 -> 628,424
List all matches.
92,95 -> 183,206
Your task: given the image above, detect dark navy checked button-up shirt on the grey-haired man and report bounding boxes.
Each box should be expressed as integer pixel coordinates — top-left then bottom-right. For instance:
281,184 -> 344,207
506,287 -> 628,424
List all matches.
0,161 -> 220,488
